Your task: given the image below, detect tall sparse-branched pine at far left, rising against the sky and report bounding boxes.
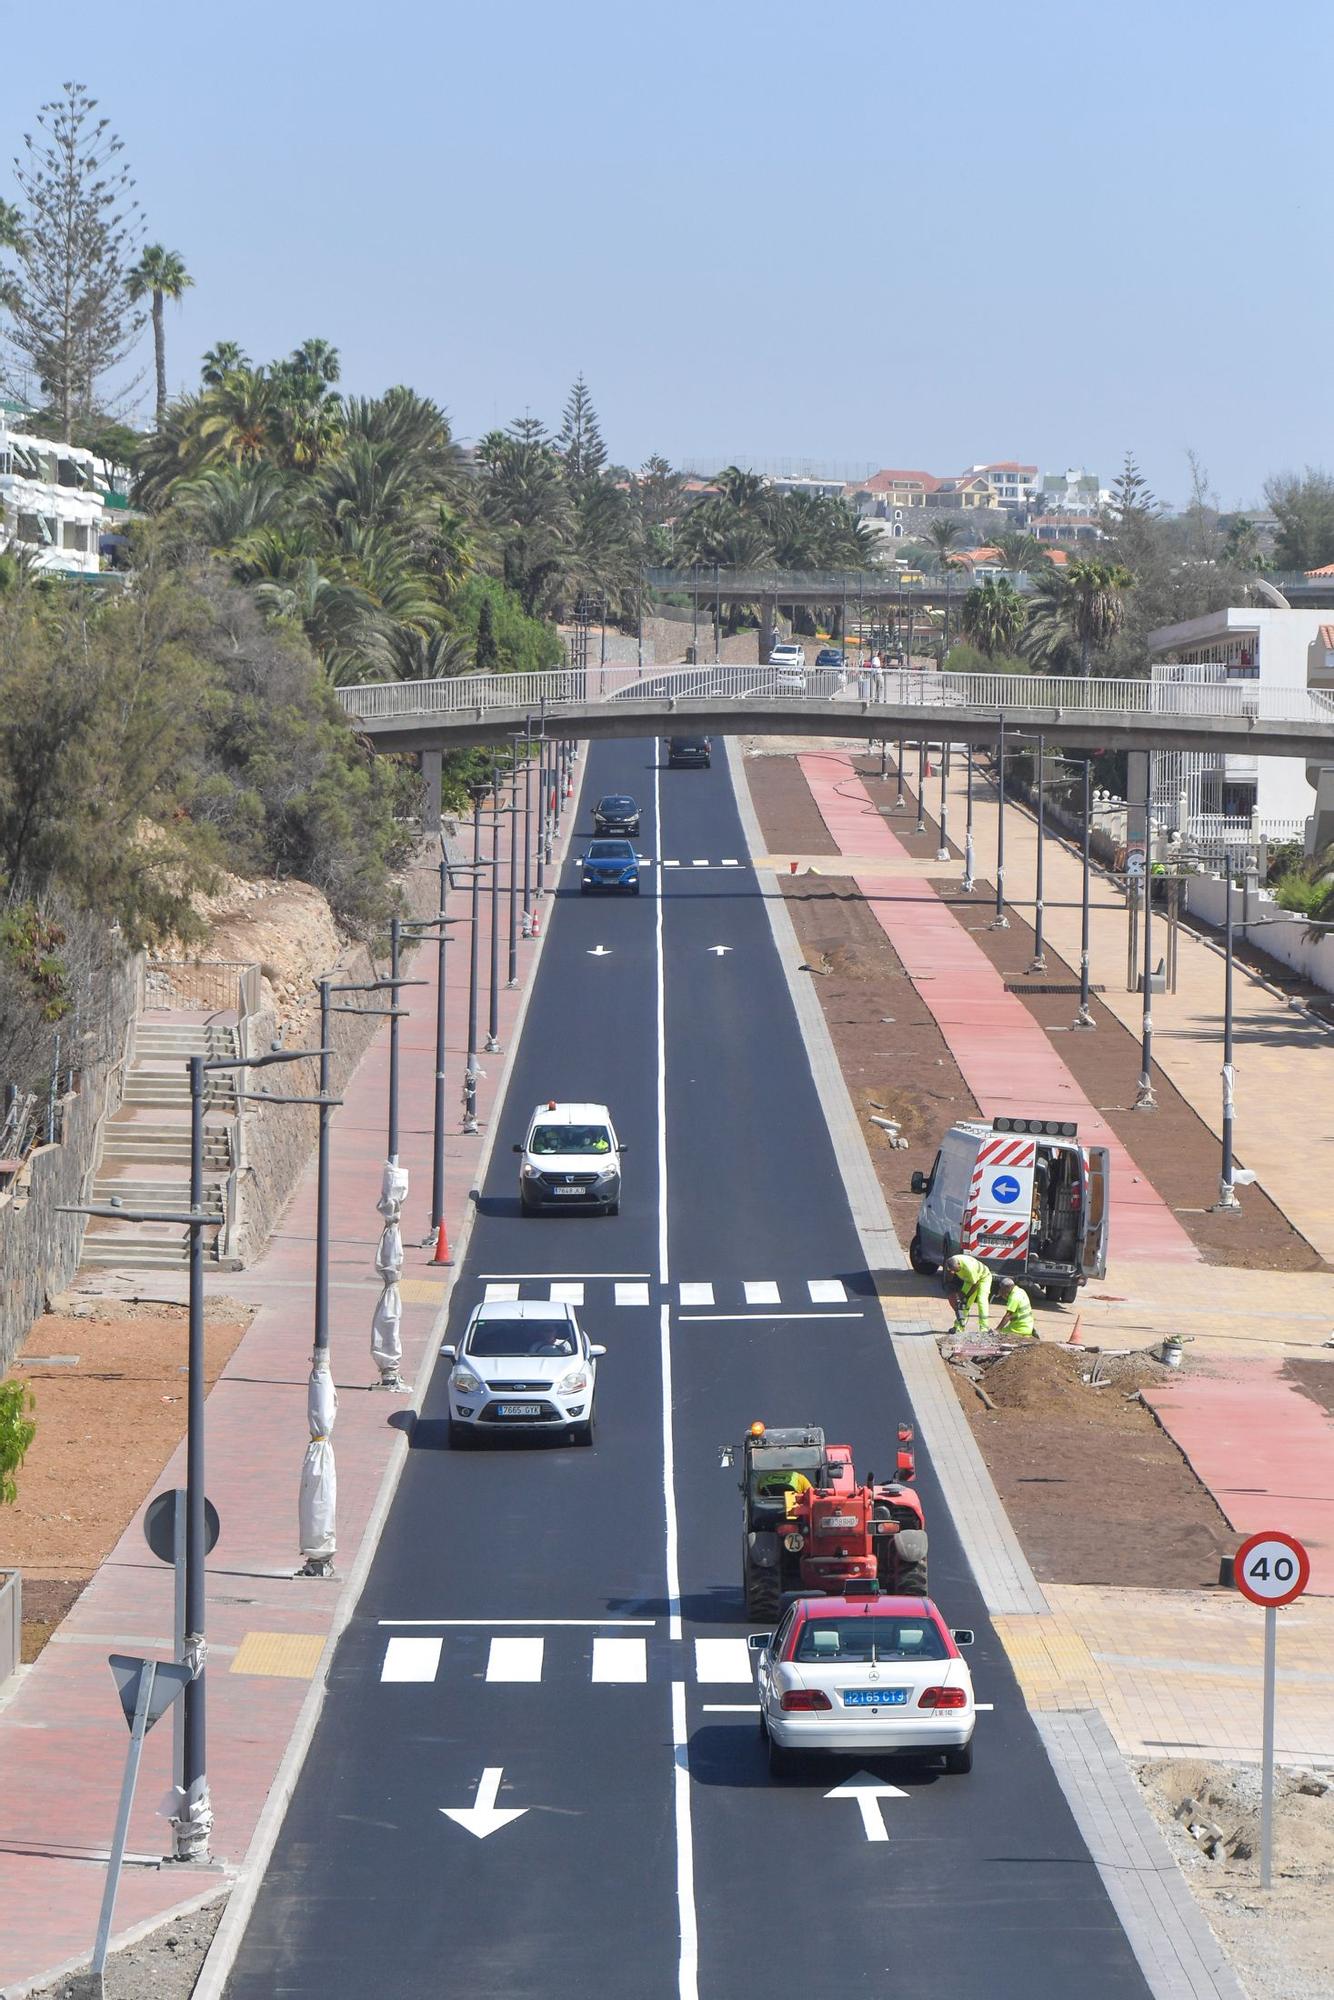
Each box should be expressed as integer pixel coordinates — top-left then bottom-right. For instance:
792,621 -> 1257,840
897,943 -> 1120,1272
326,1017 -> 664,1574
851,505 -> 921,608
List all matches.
4,84 -> 144,438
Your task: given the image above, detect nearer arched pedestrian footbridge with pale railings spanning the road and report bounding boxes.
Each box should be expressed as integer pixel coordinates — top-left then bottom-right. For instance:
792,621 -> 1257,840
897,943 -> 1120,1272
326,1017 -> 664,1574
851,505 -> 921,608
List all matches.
338,666 -> 1334,764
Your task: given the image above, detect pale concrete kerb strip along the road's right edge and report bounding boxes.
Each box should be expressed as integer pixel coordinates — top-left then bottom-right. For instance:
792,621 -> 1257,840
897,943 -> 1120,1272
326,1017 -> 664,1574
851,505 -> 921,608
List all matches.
728,740 -> 1246,2000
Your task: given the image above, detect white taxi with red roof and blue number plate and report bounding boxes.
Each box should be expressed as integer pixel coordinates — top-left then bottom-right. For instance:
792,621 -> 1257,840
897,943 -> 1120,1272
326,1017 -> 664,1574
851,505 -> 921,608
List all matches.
750,1584 -> 976,1776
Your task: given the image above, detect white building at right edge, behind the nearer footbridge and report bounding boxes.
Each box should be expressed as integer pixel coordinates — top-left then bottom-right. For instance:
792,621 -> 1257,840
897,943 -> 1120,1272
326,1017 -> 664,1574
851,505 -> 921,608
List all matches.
1148,606 -> 1334,840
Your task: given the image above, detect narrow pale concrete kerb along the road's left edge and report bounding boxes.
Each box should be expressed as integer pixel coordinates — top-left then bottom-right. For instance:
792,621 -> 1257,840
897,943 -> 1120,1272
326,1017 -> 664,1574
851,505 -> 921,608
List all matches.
14,758 -> 586,2000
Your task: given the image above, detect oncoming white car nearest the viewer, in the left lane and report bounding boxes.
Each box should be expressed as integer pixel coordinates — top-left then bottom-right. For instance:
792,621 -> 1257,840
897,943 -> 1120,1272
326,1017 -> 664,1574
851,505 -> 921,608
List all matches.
442,1298 -> 606,1446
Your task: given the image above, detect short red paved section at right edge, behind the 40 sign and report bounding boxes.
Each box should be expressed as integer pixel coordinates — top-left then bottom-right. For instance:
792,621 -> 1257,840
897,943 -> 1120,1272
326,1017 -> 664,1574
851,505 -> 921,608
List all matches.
1144,1356 -> 1334,1598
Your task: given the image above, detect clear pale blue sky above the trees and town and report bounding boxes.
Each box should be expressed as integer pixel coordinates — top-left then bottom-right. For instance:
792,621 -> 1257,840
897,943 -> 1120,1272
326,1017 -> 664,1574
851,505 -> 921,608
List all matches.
0,0 -> 1334,506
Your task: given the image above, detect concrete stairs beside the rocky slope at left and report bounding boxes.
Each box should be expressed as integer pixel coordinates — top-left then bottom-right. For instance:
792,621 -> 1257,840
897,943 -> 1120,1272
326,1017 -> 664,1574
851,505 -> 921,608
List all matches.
82,1014 -> 240,1270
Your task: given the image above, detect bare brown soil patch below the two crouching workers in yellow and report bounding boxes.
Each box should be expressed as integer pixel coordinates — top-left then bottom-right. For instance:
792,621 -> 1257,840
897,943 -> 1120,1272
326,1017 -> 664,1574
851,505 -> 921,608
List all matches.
950,1342 -> 1238,1590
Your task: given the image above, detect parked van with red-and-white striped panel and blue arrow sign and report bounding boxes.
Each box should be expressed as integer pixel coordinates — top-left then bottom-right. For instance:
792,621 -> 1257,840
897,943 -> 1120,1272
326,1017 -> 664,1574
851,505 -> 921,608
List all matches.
908,1118 -> 1110,1304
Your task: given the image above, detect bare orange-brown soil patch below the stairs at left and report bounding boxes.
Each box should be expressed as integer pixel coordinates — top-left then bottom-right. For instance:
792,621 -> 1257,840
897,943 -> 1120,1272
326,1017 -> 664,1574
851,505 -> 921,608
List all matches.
0,1298 -> 252,1660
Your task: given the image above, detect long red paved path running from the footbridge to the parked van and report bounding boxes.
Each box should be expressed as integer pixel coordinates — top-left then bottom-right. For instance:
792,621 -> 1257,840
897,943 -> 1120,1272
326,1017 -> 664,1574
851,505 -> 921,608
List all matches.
798,752 -> 1200,1264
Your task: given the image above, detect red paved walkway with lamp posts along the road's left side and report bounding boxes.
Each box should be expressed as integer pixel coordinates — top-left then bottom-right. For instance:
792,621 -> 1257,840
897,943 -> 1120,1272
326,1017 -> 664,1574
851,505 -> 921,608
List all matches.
0,766 -> 582,1988
